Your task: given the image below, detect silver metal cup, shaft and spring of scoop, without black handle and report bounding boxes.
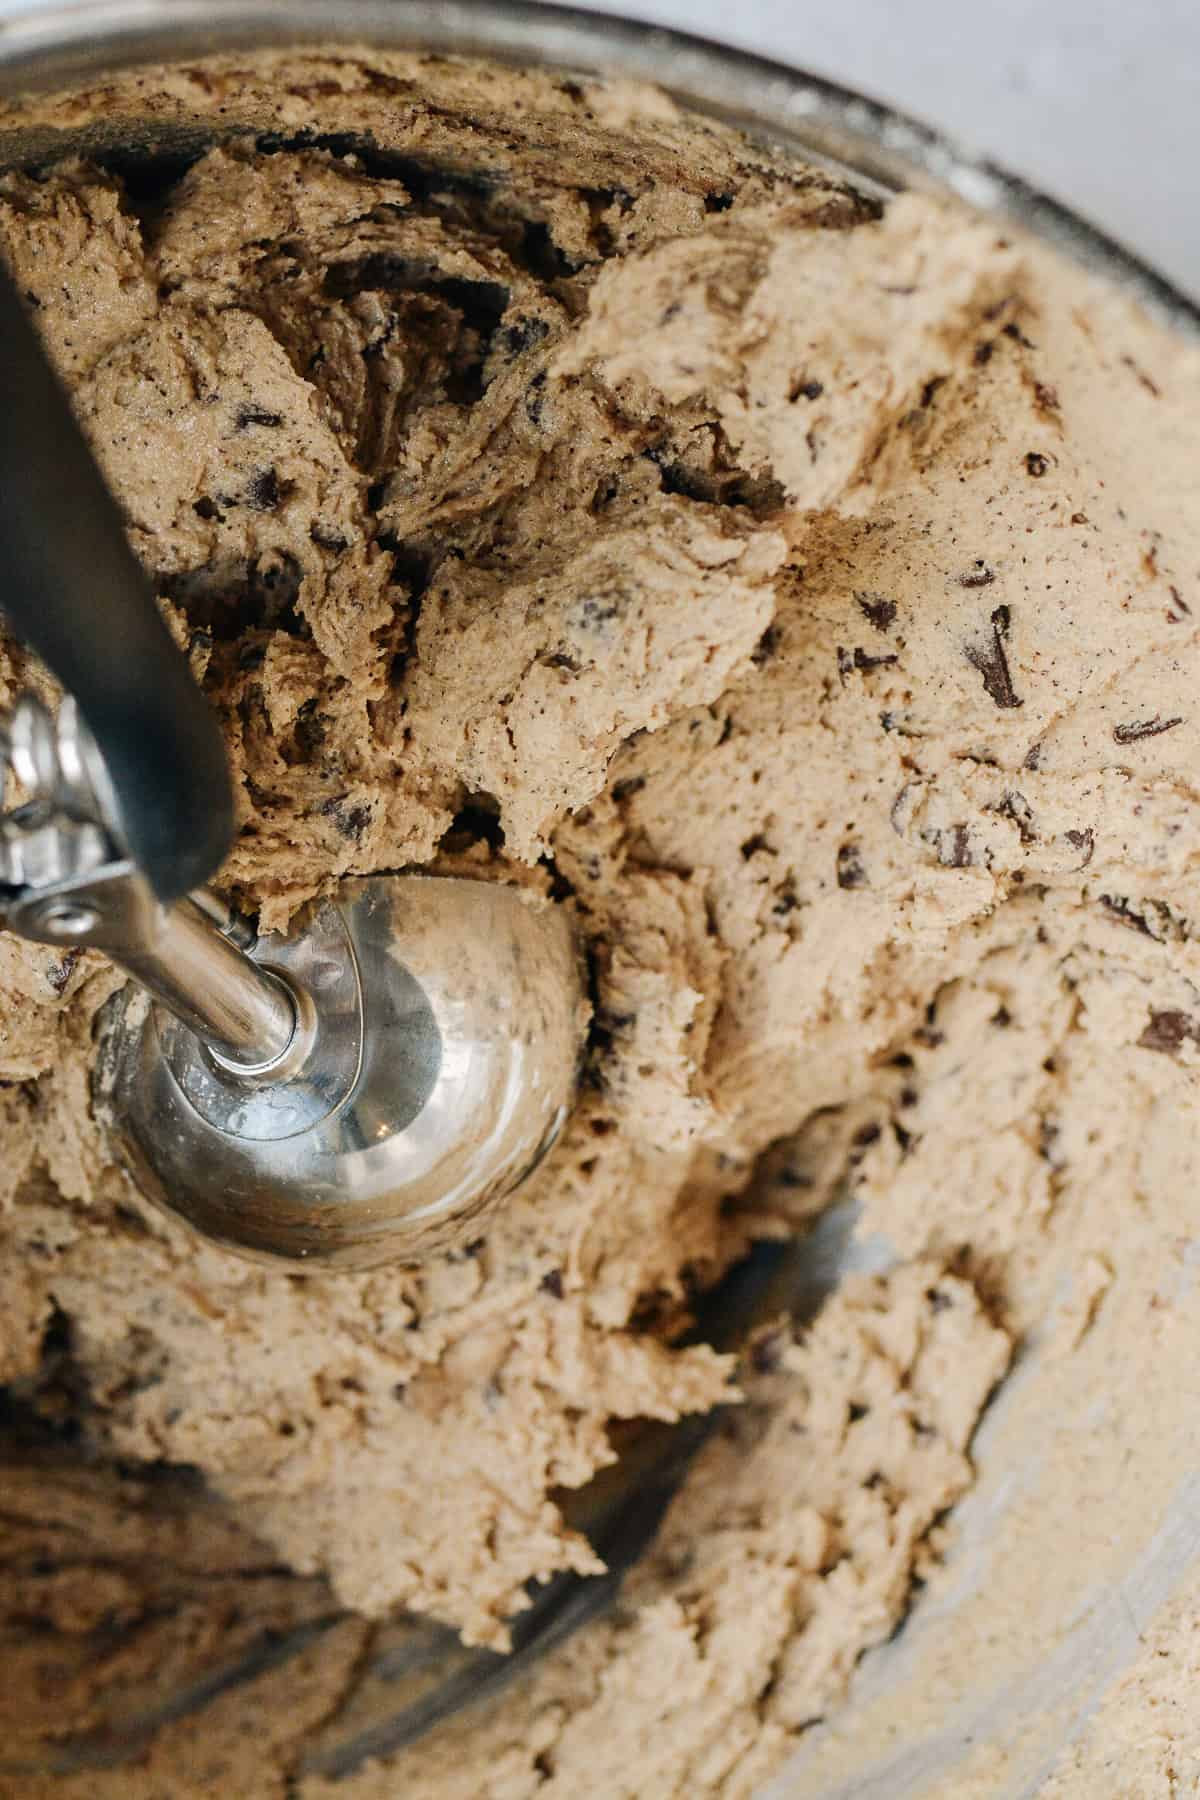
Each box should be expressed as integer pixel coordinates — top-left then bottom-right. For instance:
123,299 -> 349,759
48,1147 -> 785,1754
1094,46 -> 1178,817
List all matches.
0,697 -> 585,1269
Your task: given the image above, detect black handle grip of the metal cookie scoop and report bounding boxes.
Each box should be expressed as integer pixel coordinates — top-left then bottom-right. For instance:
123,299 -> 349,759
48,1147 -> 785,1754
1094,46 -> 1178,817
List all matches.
0,265 -> 234,900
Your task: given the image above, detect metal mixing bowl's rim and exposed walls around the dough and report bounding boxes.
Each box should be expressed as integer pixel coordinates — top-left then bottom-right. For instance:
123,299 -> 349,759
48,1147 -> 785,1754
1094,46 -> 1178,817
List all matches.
0,0 -> 1200,1800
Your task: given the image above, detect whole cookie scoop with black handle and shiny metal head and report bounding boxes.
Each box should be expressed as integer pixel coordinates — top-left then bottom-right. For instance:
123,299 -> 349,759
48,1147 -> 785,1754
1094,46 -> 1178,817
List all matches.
0,270 -> 585,1267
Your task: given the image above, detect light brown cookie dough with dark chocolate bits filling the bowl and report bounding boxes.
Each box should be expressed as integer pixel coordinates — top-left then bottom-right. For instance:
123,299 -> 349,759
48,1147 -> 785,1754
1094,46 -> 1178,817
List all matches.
0,42 -> 1200,1800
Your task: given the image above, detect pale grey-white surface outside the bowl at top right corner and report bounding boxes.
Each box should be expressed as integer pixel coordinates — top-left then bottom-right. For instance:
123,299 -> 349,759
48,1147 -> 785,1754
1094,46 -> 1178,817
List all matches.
564,0 -> 1200,299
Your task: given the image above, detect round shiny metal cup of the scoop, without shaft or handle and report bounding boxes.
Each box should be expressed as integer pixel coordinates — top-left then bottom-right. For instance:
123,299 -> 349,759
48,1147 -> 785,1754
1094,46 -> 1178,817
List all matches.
97,875 -> 579,1269
